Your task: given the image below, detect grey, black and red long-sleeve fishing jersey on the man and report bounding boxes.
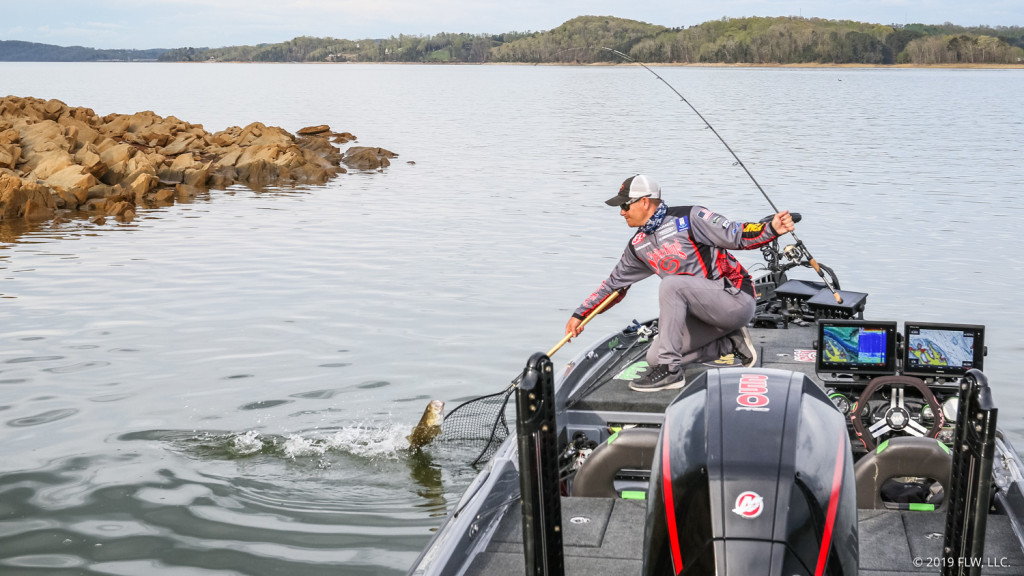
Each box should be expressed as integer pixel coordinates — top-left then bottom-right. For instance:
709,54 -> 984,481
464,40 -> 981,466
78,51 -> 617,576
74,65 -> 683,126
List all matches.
572,206 -> 778,319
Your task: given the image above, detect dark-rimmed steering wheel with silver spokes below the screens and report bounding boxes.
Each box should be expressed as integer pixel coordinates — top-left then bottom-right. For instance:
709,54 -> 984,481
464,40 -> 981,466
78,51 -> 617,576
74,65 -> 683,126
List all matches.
850,376 -> 946,452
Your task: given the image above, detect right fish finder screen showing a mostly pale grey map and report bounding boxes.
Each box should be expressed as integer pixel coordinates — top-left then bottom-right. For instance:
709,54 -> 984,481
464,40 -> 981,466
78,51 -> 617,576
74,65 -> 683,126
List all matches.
903,322 -> 985,376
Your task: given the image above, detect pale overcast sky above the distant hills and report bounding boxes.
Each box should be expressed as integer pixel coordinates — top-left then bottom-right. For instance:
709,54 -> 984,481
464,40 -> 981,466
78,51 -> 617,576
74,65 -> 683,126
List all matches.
0,0 -> 1024,48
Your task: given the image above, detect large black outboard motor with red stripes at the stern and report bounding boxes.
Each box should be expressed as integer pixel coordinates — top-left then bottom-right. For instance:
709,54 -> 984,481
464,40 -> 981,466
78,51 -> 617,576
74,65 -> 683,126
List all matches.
644,368 -> 858,576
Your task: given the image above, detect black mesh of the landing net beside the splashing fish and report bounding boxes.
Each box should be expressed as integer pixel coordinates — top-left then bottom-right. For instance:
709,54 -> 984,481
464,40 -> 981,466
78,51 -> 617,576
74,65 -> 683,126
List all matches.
438,385 -> 515,465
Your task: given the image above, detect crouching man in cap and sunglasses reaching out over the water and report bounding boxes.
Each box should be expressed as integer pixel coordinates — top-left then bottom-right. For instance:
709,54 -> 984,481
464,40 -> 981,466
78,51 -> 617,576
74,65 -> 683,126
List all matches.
565,174 -> 794,392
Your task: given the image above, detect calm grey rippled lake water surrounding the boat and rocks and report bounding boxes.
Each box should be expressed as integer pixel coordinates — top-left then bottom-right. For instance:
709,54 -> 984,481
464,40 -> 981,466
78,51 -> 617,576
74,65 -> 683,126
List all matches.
0,63 -> 1024,576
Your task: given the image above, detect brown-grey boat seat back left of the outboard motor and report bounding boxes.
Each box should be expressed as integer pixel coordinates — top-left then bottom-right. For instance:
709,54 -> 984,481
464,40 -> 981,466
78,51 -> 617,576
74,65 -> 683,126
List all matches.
572,428 -> 662,498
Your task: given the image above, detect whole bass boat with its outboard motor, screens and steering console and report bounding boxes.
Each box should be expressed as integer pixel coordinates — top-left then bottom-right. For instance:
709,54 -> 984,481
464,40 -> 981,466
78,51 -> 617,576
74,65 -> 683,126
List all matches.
409,216 -> 1024,576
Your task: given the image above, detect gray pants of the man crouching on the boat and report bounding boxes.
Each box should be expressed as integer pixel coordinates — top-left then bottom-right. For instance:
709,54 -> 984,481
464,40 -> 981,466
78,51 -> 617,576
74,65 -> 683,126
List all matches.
647,276 -> 755,366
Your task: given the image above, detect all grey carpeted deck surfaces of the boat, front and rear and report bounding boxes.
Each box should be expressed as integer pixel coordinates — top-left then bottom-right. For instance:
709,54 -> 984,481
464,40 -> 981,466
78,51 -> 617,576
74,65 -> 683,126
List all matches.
458,327 -> 1024,576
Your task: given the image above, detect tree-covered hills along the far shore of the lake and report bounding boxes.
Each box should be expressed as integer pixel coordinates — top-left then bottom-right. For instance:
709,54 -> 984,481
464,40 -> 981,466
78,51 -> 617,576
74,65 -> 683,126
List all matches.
0,16 -> 1024,66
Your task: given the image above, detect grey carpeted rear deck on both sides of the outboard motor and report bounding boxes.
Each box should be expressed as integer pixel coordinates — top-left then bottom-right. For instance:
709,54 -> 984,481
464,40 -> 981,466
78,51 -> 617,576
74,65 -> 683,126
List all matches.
466,498 -> 1024,576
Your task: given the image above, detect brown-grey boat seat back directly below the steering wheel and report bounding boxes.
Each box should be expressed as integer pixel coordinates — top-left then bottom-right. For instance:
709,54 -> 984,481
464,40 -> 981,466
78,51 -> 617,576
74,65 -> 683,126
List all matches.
853,436 -> 953,509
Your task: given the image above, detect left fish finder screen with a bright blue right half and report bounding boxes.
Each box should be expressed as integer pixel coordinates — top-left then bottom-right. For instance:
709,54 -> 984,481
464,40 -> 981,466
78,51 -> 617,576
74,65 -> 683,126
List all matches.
816,320 -> 896,374
